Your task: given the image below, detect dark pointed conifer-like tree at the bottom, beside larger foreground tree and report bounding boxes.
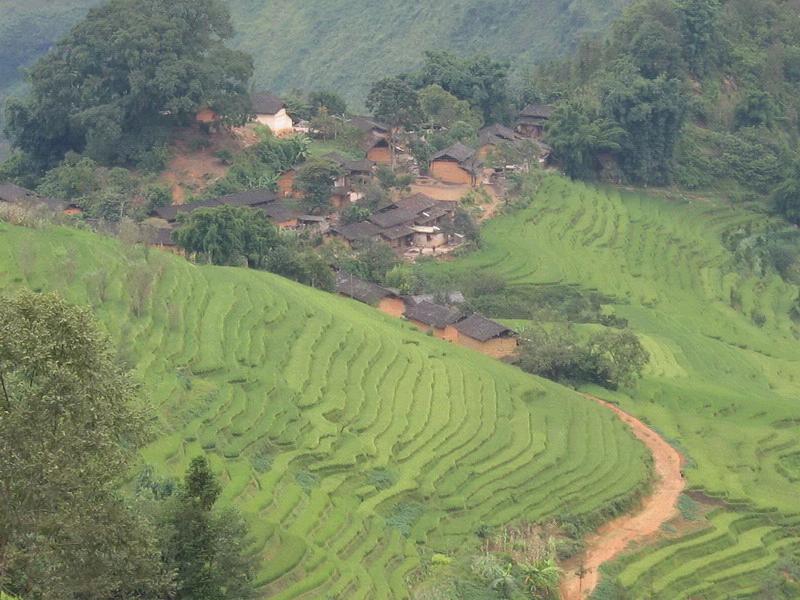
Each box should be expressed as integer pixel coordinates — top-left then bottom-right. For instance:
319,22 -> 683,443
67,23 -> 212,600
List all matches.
164,456 -> 253,600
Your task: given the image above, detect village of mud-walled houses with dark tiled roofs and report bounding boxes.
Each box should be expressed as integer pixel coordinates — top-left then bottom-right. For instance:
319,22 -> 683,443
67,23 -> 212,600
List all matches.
0,93 -> 552,358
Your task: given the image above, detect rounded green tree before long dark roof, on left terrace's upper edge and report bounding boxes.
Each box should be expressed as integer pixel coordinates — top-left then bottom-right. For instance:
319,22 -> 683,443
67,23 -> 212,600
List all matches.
173,205 -> 281,268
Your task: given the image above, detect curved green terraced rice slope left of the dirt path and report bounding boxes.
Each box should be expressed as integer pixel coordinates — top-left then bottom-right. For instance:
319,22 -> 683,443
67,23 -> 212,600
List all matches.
0,224 -> 649,600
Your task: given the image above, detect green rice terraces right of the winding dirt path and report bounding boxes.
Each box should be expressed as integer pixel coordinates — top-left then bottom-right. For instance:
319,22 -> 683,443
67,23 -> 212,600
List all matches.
430,176 -> 800,599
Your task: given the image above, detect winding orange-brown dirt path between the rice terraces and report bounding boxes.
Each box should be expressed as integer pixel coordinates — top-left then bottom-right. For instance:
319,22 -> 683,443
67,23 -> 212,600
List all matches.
561,394 -> 686,600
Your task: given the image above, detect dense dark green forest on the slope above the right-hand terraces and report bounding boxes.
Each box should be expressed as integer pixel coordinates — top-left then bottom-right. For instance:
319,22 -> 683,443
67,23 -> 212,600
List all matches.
531,0 -> 800,197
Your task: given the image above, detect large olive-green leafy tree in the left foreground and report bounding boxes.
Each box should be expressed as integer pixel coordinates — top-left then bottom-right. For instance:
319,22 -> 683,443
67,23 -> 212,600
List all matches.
0,292 -> 169,600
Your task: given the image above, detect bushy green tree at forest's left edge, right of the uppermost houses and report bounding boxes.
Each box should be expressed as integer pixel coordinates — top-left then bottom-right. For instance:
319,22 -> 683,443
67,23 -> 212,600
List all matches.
546,102 -> 625,179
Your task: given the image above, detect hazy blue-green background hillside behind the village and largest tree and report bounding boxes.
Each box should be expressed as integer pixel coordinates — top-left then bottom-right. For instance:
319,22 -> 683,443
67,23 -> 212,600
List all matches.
0,0 -> 627,116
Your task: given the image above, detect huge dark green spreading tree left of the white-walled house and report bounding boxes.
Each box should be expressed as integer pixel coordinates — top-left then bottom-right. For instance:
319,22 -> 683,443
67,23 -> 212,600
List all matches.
6,0 -> 253,163
